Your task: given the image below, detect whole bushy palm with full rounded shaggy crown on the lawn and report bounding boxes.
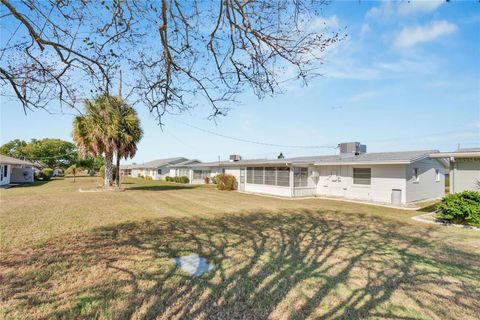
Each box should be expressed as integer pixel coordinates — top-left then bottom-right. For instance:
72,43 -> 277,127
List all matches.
72,95 -> 142,188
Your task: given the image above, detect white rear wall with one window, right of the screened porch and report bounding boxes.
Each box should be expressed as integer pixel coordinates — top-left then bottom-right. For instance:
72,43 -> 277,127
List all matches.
317,165 -> 407,204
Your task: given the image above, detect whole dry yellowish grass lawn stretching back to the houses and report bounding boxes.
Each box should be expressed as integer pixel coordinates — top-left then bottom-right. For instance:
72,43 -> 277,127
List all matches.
0,177 -> 480,319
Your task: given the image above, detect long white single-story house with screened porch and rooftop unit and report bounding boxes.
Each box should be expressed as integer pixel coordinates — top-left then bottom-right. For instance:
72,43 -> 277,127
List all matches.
171,142 -> 448,205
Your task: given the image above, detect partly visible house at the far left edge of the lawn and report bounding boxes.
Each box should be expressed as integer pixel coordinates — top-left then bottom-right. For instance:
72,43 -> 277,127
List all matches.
0,155 -> 34,186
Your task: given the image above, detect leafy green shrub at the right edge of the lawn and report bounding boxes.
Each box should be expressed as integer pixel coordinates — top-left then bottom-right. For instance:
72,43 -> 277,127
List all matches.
437,191 -> 480,226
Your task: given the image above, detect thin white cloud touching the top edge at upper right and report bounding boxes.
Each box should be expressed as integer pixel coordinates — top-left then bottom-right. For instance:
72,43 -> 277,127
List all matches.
367,0 -> 446,19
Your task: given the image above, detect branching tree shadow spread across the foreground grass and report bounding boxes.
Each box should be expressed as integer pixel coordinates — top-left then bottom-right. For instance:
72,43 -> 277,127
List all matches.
0,210 -> 480,319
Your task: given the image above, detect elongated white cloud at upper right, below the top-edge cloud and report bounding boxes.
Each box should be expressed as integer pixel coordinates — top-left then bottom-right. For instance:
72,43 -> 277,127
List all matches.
394,20 -> 458,47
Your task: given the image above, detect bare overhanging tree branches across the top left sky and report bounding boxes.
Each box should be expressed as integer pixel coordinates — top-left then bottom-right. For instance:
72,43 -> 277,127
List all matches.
0,0 -> 345,122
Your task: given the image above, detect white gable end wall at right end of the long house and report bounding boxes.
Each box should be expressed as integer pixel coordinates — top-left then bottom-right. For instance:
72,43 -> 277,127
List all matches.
405,159 -> 445,202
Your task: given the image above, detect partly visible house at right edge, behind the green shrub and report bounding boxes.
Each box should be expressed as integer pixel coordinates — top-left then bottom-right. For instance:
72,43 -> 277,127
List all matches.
431,148 -> 480,193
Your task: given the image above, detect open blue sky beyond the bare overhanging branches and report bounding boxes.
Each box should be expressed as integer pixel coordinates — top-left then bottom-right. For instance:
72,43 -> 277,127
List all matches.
0,0 -> 480,162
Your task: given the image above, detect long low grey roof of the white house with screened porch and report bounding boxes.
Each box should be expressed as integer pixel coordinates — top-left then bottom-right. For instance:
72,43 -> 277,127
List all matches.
174,150 -> 438,168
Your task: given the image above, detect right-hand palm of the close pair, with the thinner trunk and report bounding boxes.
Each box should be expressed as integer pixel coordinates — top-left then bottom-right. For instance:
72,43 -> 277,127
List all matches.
111,97 -> 143,188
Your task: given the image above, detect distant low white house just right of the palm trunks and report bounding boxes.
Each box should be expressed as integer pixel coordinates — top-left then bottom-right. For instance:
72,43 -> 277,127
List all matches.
120,157 -> 189,180
